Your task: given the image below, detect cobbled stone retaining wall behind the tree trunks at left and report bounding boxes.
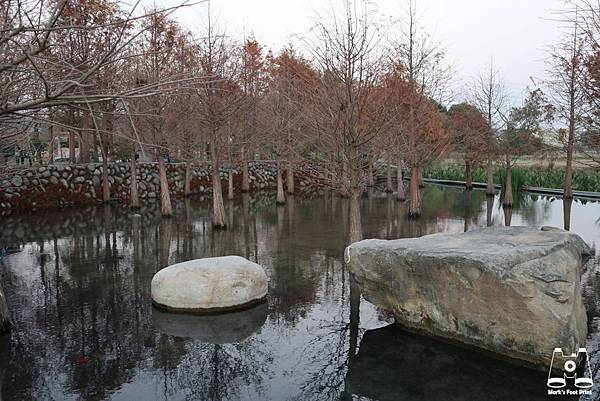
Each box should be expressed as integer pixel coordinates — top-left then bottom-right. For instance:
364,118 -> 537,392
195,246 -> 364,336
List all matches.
0,161 -> 322,214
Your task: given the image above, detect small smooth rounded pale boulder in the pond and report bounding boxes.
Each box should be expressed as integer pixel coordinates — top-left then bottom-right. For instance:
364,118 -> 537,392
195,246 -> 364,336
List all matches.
151,256 -> 268,313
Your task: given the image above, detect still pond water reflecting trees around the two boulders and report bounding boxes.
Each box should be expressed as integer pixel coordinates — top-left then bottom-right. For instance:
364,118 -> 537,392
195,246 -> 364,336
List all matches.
0,186 -> 600,401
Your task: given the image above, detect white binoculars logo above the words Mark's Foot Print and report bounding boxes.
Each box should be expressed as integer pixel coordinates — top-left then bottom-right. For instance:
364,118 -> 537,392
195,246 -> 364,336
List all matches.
548,348 -> 594,389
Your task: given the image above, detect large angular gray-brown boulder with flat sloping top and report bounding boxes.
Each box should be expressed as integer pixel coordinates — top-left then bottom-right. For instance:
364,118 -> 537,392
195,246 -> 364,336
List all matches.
345,227 -> 591,369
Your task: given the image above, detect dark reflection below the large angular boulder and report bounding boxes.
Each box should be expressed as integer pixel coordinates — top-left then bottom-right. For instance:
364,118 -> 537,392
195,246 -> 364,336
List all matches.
346,325 -> 577,401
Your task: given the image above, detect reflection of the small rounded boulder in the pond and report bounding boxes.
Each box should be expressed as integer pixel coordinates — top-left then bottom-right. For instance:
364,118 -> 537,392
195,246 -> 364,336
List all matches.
152,302 -> 268,344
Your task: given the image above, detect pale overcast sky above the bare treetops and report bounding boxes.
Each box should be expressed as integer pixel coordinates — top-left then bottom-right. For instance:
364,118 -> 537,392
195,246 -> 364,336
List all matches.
157,0 -> 564,101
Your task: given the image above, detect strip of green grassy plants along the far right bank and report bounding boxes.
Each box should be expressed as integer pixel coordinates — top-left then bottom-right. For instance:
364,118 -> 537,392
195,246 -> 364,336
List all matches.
424,166 -> 600,192
